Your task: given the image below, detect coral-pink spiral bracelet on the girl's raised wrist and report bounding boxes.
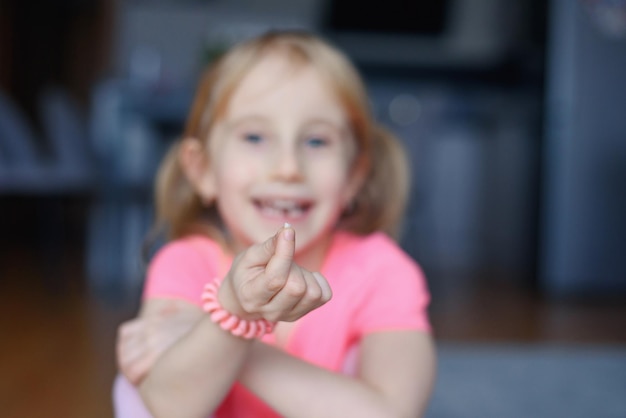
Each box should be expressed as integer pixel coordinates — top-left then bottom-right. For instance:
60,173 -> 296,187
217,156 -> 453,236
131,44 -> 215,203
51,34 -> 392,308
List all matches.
202,279 -> 275,339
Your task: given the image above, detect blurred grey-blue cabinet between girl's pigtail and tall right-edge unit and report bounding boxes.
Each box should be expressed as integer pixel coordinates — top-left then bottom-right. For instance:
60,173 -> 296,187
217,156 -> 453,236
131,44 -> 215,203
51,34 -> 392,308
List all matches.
369,79 -> 541,282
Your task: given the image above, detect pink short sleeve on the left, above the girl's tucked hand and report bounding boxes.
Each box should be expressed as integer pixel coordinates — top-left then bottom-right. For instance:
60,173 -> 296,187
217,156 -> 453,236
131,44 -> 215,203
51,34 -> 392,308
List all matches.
143,239 -> 218,306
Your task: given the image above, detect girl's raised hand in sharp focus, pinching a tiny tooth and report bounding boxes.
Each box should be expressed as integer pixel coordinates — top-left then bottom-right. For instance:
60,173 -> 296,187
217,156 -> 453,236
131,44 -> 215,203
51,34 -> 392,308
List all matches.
218,225 -> 332,322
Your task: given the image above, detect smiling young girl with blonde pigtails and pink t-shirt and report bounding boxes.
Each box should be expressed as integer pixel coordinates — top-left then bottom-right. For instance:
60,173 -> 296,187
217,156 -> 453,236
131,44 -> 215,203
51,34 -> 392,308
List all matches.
114,31 -> 435,418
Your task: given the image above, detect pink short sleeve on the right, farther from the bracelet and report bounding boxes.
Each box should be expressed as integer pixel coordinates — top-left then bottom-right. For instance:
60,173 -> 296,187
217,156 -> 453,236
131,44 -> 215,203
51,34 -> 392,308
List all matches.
348,238 -> 431,335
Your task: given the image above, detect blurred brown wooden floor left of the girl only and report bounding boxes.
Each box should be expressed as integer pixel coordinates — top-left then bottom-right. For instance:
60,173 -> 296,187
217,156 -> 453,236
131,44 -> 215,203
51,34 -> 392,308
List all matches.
0,247 -> 132,418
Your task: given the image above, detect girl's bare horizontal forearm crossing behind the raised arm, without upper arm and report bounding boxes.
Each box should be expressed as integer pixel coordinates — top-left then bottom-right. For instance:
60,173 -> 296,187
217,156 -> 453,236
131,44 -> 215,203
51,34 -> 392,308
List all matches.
239,343 -> 428,418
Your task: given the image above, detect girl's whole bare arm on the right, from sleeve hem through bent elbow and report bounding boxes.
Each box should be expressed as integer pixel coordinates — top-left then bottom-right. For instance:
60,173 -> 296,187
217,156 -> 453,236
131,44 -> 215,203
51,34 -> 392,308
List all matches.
240,331 -> 436,418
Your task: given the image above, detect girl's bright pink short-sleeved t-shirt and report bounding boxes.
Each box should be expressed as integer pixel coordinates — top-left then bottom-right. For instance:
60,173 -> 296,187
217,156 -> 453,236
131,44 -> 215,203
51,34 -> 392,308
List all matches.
144,232 -> 430,418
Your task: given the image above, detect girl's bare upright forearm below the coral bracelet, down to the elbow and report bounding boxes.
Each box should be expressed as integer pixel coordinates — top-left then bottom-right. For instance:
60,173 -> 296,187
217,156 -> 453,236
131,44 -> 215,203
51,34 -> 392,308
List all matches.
139,316 -> 251,418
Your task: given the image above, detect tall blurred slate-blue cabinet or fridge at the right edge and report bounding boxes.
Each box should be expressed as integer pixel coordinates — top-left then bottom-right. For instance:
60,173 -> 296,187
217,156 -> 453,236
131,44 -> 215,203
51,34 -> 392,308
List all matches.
540,0 -> 626,296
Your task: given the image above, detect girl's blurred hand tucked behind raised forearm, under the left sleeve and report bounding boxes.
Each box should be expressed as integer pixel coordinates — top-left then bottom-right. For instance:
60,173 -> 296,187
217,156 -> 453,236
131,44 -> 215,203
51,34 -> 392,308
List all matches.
116,300 -> 203,385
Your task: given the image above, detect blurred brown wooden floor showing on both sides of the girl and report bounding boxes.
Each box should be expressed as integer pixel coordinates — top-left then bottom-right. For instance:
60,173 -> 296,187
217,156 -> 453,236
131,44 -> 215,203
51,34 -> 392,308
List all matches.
0,198 -> 626,418
